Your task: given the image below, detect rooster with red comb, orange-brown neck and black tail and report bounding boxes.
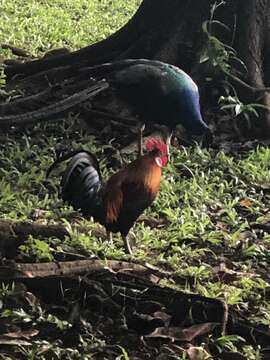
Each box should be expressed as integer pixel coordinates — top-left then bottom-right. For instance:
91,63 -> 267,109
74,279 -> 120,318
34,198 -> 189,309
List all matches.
48,129 -> 170,254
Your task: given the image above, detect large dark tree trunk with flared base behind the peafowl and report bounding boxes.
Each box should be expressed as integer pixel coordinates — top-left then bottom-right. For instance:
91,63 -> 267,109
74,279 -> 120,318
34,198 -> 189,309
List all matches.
3,0 -> 270,134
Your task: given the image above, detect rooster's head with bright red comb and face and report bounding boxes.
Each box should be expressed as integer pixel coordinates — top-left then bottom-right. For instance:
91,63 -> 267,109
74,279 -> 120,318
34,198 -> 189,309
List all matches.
145,134 -> 171,167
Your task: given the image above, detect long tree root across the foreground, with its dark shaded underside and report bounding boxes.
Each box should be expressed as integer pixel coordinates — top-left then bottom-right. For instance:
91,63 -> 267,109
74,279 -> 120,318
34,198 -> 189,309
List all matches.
3,260 -> 270,345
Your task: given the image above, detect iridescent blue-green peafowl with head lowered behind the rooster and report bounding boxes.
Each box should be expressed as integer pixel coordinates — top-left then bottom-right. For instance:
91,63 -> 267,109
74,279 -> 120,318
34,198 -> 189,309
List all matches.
0,59 -> 209,135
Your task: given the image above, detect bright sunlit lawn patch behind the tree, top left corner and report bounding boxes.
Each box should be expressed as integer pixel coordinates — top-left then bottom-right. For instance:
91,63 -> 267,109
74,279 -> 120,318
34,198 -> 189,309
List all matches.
0,0 -> 141,56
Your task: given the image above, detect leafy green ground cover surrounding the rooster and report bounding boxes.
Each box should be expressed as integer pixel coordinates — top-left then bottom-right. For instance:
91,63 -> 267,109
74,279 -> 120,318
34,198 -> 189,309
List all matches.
0,125 -> 270,304
